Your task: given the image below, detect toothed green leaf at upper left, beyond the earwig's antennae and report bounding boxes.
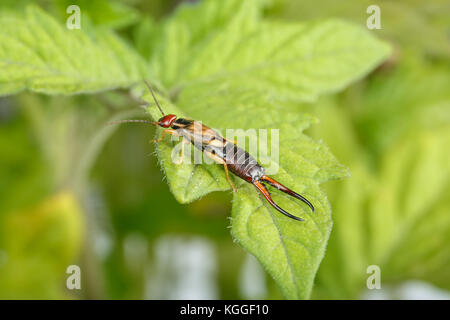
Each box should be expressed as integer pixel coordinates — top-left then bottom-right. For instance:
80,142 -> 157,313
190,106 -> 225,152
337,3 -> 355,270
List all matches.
0,6 -> 146,94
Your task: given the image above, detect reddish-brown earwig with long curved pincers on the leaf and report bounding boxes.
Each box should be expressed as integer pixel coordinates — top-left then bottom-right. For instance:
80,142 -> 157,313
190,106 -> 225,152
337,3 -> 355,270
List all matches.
111,81 -> 314,221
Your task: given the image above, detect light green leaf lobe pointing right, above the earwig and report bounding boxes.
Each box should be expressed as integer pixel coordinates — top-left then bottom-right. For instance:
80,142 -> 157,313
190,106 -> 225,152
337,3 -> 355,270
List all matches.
179,20 -> 389,101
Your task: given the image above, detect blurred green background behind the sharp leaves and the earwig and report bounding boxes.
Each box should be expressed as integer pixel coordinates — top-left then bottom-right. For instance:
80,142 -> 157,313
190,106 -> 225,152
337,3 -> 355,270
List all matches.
0,0 -> 450,299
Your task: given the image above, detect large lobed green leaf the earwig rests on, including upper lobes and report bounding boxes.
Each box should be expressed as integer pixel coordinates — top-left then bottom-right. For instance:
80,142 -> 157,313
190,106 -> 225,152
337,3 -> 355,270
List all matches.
143,1 -> 389,299
